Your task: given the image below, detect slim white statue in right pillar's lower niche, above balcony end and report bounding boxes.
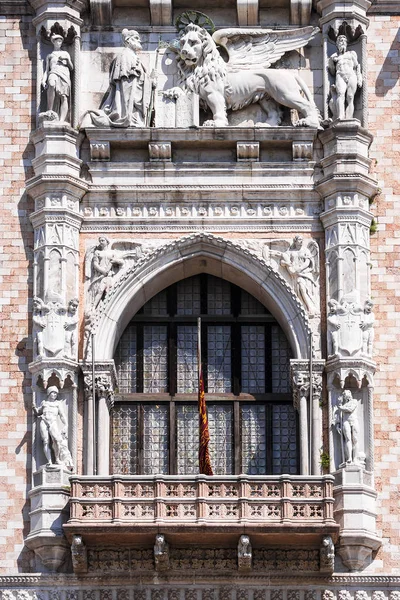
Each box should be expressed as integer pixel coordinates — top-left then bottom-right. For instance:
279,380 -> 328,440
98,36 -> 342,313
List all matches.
335,390 -> 359,464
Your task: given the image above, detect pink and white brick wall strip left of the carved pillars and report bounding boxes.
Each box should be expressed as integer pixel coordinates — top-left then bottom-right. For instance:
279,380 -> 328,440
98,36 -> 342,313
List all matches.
0,17 -> 35,573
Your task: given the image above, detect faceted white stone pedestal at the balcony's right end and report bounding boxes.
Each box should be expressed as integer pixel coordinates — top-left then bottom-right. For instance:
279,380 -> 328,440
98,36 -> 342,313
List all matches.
333,465 -> 382,571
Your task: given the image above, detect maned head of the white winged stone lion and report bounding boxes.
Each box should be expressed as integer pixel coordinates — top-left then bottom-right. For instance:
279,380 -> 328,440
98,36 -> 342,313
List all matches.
178,23 -> 226,93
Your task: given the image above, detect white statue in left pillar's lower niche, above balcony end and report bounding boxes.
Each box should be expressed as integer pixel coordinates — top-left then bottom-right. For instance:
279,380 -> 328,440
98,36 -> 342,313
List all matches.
32,385 -> 73,469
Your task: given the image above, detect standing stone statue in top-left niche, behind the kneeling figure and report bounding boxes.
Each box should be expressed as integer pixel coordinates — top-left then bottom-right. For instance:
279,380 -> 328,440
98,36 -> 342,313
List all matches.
42,33 -> 74,121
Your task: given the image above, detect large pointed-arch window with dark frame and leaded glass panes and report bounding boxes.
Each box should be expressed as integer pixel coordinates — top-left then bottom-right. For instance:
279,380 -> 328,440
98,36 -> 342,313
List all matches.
112,275 -> 298,475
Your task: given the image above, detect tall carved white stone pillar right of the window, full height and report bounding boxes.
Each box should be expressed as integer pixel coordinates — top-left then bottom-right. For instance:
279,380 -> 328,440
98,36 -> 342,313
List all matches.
316,0 -> 380,570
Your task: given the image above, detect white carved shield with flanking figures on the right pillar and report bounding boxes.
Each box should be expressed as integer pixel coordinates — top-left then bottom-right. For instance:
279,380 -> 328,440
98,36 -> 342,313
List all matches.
327,293 -> 375,358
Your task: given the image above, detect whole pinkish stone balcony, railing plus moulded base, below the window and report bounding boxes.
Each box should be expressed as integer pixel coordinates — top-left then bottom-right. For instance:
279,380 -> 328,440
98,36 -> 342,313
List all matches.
64,475 -> 339,545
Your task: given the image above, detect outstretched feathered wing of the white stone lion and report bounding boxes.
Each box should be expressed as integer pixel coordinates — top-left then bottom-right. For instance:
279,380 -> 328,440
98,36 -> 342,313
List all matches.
213,26 -> 319,72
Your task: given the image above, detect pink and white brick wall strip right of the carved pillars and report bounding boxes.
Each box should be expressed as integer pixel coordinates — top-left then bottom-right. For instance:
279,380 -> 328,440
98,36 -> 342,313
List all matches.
368,16 -> 400,574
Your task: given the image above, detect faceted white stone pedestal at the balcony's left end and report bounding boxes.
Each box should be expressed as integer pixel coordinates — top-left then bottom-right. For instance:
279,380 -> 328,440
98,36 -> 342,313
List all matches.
25,465 -> 71,571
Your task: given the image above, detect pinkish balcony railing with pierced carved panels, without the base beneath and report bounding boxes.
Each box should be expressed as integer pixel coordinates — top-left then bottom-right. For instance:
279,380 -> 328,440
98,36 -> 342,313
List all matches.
69,475 -> 334,526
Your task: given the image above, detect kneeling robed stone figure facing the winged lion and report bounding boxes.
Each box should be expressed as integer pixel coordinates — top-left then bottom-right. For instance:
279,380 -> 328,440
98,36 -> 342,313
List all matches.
82,29 -> 155,127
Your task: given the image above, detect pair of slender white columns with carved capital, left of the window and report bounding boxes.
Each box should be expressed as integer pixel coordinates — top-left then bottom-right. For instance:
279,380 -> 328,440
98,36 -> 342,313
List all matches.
81,361 -> 117,475
